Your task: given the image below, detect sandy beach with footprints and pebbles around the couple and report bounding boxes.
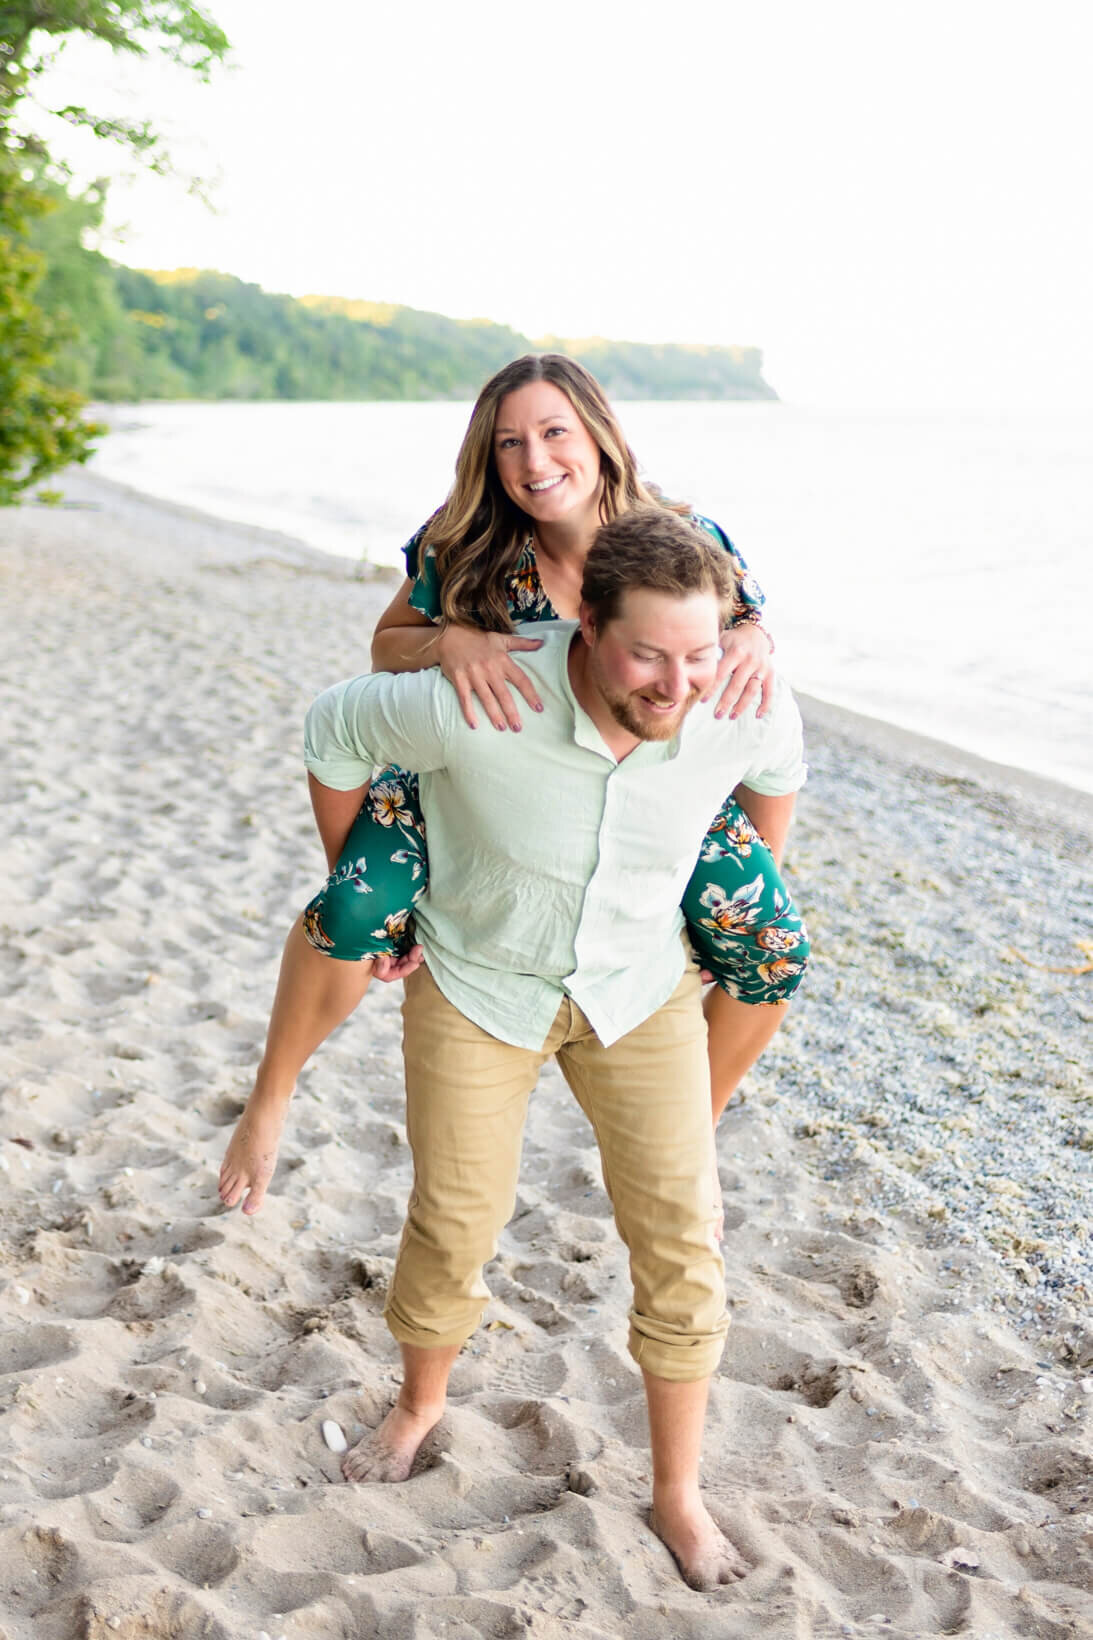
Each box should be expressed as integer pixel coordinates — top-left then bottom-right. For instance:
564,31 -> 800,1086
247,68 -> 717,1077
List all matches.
0,474 -> 1093,1640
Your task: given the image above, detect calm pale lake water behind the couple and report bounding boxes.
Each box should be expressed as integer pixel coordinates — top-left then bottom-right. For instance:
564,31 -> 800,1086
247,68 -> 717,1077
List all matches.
94,403 -> 1093,790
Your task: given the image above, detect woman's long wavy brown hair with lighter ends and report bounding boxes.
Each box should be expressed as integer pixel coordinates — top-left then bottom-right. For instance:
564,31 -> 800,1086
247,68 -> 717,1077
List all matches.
420,353 -> 689,631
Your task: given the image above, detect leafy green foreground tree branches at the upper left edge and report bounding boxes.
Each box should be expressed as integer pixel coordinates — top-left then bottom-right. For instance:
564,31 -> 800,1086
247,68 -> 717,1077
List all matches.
0,0 -> 228,505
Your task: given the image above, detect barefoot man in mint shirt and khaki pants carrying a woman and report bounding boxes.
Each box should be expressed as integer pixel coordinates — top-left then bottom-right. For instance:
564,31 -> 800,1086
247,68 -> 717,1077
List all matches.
222,508 -> 804,1589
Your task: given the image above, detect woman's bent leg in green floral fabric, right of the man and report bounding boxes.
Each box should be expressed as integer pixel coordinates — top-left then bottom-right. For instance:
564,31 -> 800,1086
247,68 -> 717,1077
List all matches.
683,797 -> 809,1122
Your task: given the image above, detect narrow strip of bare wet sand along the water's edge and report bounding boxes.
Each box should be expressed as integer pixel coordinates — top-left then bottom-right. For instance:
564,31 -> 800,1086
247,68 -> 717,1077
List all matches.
57,467 -> 1093,813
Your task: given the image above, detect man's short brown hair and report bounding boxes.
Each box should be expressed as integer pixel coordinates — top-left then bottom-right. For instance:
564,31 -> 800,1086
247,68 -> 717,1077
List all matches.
581,507 -> 737,628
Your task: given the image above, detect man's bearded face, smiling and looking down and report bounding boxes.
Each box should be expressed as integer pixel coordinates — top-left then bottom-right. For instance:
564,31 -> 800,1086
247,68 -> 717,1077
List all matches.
581,590 -> 720,740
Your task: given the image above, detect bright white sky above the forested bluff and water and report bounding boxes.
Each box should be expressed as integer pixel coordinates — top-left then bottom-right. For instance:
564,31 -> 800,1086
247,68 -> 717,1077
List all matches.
29,0 -> 1093,408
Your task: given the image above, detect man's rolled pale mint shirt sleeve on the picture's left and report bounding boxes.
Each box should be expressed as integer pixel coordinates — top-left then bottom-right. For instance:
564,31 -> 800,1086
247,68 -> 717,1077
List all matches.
304,671 -> 455,792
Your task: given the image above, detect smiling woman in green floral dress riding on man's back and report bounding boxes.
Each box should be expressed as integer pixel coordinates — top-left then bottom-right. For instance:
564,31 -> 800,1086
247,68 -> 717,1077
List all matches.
220,354 -> 807,1214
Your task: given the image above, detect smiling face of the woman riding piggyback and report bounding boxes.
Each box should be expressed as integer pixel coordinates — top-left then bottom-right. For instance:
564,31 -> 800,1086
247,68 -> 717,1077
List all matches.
494,382 -> 602,535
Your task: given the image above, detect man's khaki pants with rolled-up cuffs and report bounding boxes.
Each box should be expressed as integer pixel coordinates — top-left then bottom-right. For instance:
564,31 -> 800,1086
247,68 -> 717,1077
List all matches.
386,968 -> 729,1383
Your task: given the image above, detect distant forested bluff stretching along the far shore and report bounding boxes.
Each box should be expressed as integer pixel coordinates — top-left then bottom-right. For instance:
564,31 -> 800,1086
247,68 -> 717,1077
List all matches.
33,186 -> 776,402
